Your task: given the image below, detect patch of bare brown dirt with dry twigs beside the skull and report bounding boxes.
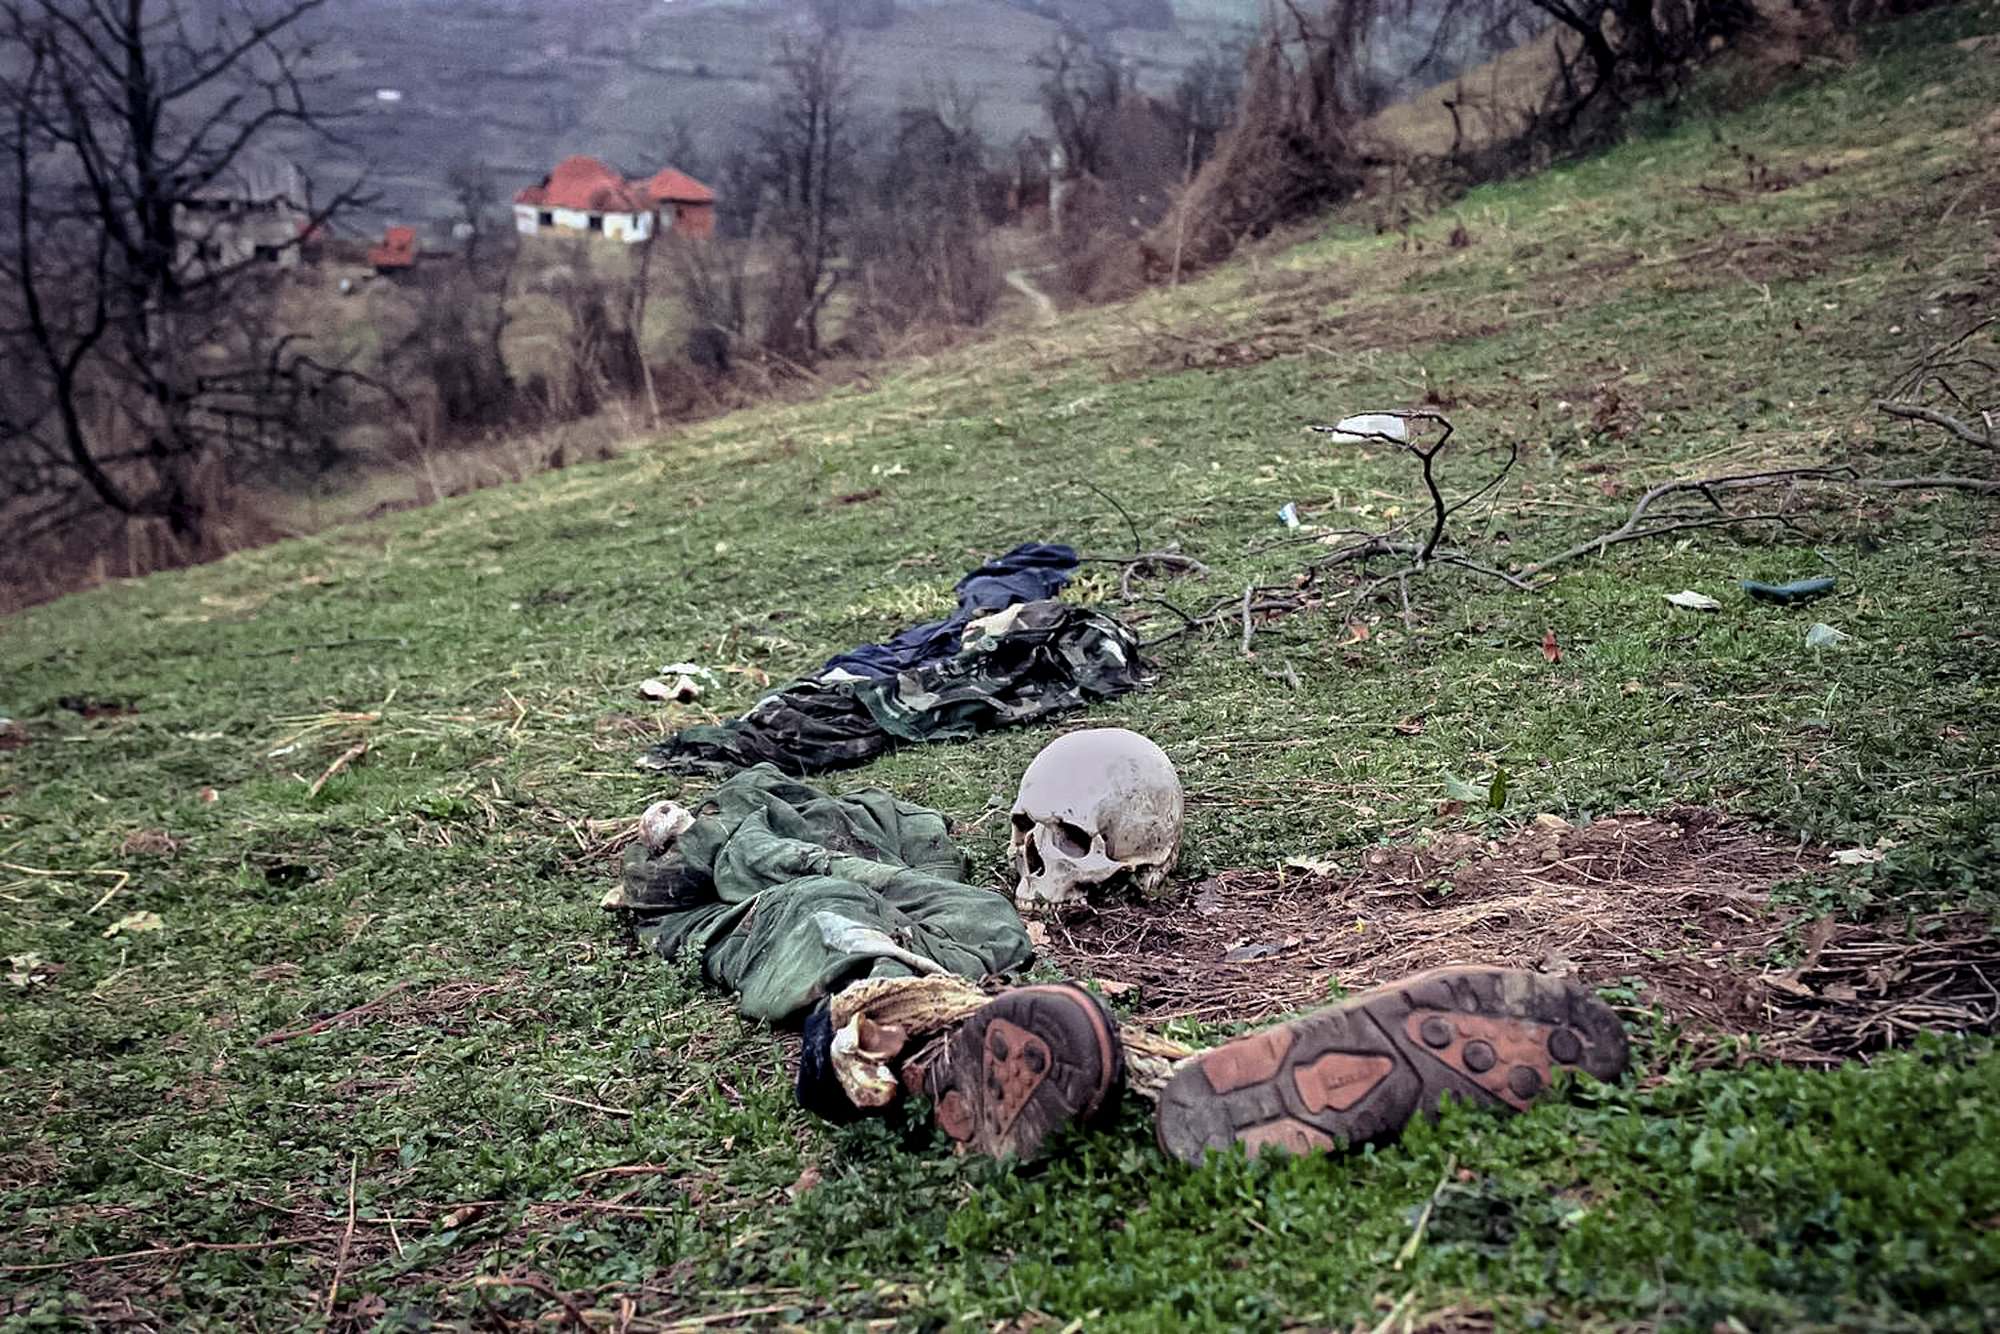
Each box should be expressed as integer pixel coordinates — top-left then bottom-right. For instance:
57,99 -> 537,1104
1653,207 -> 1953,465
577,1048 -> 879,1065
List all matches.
1048,808 -> 2000,1064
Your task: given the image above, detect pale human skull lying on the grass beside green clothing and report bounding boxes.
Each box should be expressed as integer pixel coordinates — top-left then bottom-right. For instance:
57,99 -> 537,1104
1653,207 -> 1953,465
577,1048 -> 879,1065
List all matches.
1014,728 -> 1182,908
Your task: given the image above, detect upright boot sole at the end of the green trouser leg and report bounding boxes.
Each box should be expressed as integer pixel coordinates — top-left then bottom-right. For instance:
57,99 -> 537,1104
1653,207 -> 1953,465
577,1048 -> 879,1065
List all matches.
916,986 -> 1124,1162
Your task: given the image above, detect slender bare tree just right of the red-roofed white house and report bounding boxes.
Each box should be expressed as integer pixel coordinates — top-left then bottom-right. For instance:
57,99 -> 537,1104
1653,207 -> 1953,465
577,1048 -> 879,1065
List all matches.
758,20 -> 854,360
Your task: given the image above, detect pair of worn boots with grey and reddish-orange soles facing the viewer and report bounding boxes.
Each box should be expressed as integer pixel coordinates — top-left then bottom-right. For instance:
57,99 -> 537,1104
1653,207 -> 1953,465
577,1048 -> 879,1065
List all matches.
906,968 -> 1626,1164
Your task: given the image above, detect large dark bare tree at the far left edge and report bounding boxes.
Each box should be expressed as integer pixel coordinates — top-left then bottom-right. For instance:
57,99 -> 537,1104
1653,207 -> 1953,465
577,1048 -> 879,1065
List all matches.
0,0 -> 358,548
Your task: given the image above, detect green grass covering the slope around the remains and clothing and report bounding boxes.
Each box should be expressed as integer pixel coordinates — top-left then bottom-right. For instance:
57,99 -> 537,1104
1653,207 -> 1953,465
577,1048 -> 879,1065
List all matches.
11,4 -> 2000,1330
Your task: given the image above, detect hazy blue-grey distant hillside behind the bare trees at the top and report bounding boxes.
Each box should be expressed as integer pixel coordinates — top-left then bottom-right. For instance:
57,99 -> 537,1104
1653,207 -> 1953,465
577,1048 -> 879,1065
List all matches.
274,0 -> 1258,226
